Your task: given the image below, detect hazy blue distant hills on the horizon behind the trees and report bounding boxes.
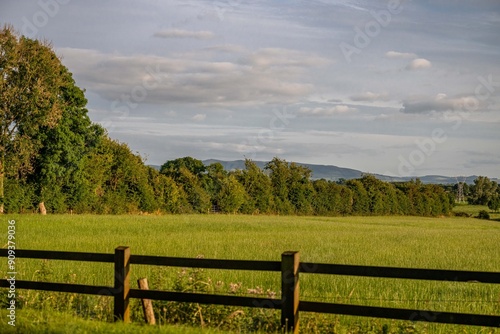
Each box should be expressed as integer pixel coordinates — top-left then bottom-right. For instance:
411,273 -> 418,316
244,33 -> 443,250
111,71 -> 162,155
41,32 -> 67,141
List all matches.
151,159 -> 500,184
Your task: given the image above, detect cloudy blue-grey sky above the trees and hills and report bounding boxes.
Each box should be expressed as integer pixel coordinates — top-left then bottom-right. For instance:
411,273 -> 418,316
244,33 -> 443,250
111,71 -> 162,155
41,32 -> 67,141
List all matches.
0,0 -> 500,177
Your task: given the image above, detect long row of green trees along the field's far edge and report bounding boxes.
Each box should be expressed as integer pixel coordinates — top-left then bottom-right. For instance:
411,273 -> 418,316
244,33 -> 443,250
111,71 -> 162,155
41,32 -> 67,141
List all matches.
0,26 -> 498,216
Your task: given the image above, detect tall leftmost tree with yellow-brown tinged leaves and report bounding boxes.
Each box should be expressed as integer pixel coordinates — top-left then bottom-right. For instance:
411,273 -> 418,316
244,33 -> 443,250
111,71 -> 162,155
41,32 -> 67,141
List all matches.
0,26 -> 65,212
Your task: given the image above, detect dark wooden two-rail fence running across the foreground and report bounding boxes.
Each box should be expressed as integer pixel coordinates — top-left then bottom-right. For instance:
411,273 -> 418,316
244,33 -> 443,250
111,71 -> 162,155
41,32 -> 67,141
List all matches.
0,246 -> 500,333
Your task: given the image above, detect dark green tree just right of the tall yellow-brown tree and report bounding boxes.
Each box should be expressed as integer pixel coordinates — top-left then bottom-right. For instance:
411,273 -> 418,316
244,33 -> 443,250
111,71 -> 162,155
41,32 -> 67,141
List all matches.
30,65 -> 104,211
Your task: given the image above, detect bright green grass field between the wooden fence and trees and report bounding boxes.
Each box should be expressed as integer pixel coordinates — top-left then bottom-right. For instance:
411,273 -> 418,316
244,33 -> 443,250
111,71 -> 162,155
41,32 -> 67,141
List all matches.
0,206 -> 500,333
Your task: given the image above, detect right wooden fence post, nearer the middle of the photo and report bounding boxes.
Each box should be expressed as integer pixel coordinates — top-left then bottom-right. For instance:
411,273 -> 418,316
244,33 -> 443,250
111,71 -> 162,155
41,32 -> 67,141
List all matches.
281,251 -> 300,333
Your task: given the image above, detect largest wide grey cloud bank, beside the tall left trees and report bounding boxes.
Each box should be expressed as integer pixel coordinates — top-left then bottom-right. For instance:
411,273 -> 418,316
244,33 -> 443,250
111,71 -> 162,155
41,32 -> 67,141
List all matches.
58,48 -> 326,109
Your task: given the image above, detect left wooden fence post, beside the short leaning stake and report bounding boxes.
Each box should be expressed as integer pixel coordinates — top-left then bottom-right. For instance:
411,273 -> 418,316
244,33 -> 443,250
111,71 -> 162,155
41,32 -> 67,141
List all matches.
114,246 -> 130,322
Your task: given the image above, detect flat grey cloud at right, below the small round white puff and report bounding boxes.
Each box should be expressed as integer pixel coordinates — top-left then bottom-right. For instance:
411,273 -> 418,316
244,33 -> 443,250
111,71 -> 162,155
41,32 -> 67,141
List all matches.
399,94 -> 479,114
